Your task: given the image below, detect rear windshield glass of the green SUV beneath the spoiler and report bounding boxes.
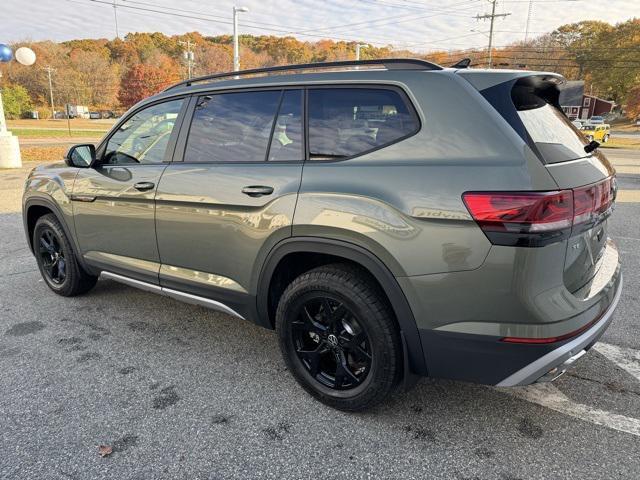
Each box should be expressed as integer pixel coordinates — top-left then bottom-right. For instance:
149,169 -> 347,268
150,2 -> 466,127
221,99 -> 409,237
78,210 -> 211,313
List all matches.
511,84 -> 588,163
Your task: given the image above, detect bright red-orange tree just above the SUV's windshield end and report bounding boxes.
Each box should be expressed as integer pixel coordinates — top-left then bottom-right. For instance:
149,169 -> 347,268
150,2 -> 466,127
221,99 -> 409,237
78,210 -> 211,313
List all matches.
118,64 -> 179,108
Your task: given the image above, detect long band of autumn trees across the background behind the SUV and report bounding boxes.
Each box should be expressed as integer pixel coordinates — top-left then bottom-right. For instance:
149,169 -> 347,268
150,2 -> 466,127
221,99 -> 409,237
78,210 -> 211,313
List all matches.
2,19 -> 640,113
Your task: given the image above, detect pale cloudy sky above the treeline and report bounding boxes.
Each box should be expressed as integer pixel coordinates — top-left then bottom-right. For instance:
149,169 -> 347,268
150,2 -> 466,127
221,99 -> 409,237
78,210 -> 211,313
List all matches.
5,0 -> 640,52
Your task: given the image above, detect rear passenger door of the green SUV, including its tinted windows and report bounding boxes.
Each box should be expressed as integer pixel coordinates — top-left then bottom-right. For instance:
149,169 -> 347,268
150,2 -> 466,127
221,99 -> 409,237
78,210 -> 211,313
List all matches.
156,89 -> 305,311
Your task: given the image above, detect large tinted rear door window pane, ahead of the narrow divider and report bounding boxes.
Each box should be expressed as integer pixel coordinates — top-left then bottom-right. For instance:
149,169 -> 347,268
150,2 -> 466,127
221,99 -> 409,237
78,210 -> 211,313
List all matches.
184,90 -> 282,162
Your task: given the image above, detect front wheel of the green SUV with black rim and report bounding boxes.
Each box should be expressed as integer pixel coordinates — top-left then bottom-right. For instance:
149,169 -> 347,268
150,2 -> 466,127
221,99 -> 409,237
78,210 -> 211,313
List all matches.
33,213 -> 98,297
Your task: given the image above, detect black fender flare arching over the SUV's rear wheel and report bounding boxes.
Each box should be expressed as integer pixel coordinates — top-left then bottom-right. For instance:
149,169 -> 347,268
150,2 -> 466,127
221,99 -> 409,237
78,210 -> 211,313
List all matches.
256,237 -> 427,377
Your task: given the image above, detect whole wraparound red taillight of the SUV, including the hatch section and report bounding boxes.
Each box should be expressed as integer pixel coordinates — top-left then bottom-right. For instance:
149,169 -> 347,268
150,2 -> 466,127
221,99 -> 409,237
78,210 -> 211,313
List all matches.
462,178 -> 613,247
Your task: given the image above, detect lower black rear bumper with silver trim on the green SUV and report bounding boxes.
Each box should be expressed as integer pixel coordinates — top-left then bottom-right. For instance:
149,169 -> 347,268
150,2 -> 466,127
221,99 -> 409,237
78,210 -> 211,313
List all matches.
420,274 -> 622,387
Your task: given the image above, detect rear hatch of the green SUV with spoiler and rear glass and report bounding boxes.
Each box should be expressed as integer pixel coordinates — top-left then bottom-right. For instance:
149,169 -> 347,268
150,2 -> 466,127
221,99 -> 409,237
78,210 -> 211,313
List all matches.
459,70 -> 616,293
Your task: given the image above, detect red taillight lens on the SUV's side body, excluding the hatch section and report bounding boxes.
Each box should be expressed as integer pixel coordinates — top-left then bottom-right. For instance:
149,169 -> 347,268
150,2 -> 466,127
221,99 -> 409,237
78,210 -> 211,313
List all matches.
462,190 -> 573,232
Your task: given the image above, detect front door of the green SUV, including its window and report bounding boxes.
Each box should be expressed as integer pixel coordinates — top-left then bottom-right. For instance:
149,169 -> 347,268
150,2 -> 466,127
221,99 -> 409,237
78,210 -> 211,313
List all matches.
72,99 -> 186,283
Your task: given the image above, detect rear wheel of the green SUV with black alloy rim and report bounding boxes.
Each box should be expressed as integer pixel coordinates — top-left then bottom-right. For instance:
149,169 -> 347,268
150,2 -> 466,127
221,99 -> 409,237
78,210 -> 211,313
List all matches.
276,264 -> 402,411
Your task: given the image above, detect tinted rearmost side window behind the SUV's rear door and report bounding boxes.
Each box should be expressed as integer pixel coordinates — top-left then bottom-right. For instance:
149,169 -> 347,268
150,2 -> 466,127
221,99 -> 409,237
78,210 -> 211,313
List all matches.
308,88 -> 419,160
